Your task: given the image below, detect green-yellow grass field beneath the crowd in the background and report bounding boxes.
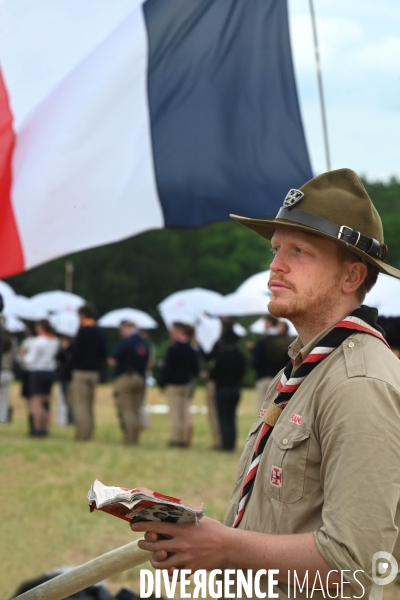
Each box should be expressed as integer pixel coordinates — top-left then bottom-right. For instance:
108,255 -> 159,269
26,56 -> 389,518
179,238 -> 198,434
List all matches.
0,385 -> 400,600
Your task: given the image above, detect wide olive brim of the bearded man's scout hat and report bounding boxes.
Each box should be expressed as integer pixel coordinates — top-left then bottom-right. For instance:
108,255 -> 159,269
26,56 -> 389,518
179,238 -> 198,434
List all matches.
229,215 -> 400,279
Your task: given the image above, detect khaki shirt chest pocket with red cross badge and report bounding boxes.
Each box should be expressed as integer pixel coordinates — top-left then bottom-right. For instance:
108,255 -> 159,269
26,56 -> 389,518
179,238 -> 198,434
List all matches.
260,423 -> 310,504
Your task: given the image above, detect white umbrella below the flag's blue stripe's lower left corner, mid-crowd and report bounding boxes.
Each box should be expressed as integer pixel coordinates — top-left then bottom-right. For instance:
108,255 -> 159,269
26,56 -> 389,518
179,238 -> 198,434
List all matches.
157,288 -> 223,329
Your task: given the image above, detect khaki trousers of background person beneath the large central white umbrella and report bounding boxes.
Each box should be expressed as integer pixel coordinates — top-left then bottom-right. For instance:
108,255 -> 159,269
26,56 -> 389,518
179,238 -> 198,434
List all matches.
165,385 -> 191,445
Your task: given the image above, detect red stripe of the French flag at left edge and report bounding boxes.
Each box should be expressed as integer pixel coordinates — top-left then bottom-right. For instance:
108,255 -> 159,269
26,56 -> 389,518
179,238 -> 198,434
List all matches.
0,71 -> 24,277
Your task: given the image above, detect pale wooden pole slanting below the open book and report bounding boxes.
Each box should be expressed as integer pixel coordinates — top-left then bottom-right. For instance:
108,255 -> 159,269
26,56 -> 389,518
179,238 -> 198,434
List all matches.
15,540 -> 152,600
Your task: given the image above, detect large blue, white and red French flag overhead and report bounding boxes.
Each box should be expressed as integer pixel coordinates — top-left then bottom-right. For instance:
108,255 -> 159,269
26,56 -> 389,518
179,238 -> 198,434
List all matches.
0,0 -> 312,277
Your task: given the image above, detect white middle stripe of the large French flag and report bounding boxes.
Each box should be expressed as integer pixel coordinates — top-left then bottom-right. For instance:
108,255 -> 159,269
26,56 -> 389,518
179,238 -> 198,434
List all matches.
0,0 -> 164,268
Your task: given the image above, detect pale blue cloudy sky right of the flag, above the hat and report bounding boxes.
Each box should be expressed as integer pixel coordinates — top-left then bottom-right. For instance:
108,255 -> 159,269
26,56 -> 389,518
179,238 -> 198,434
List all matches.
289,0 -> 400,181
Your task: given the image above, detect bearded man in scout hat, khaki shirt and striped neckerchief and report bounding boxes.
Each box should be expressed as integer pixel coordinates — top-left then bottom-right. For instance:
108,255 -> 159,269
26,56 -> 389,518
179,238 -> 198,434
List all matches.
132,169 -> 400,600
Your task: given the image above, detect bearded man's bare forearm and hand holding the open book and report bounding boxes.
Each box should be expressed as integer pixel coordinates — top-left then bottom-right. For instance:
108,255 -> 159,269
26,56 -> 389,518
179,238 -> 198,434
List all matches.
131,517 -> 341,586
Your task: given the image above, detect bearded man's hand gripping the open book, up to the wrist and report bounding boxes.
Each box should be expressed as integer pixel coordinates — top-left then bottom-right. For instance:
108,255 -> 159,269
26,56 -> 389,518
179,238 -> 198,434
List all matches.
131,517 -> 235,575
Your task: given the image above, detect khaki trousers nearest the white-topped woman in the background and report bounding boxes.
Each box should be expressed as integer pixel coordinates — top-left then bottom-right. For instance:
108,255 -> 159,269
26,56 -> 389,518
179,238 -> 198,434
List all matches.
70,370 -> 99,440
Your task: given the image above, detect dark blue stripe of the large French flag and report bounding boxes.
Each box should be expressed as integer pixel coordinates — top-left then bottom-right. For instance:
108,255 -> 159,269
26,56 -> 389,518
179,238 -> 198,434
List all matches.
143,0 -> 313,226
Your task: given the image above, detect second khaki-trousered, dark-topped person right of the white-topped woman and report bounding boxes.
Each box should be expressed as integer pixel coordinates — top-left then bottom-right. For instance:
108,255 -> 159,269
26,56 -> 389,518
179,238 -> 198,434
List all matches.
108,321 -> 149,444
